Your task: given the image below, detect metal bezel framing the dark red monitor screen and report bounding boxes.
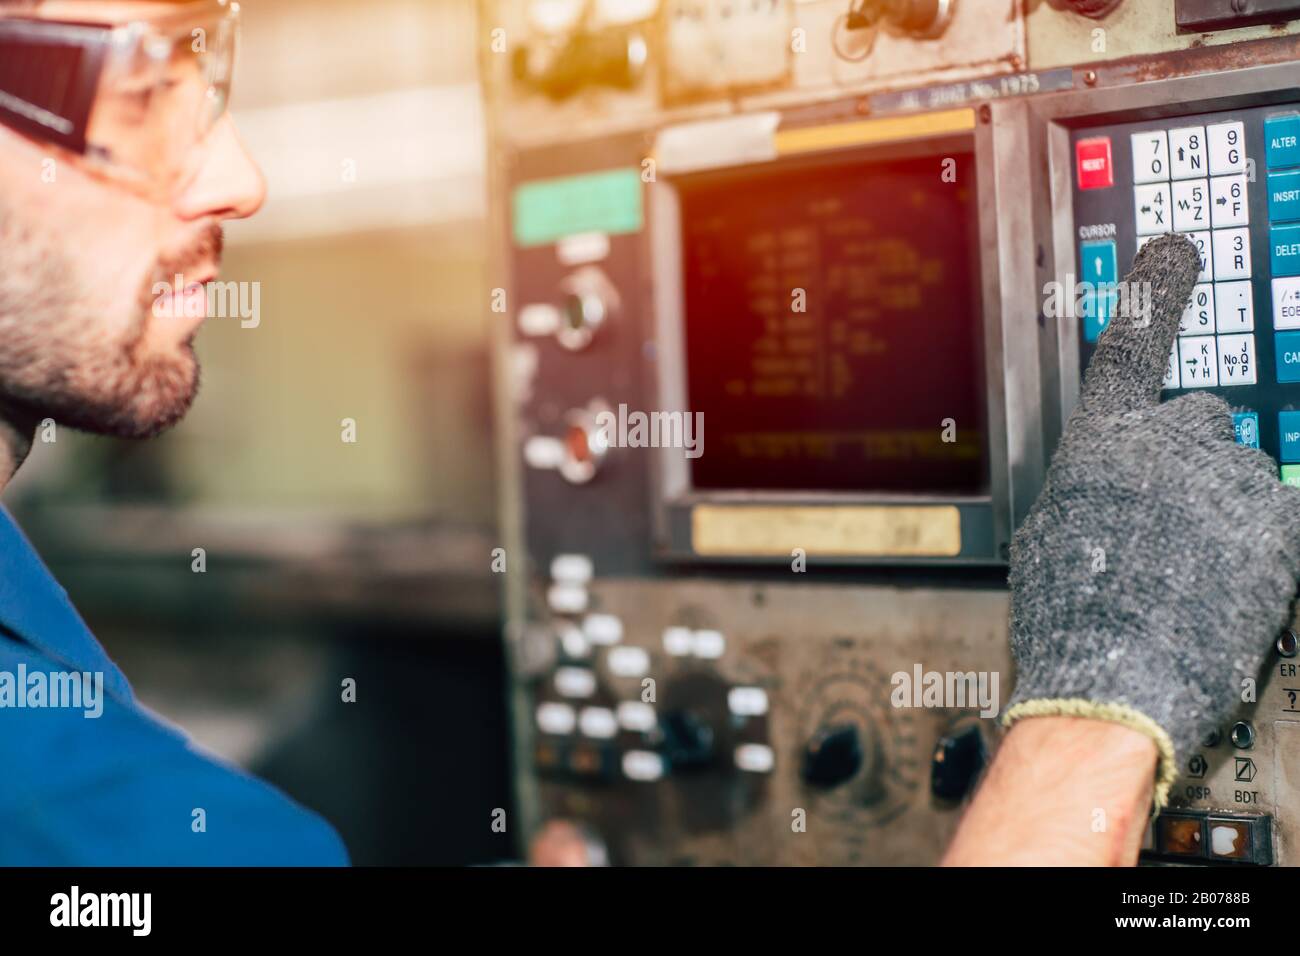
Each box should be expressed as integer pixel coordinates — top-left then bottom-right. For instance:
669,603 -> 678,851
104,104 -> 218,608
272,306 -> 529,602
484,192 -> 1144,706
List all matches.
647,113 -> 1043,566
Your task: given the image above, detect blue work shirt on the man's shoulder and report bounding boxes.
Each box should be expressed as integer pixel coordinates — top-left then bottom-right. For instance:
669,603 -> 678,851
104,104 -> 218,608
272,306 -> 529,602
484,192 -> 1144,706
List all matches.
0,509 -> 347,866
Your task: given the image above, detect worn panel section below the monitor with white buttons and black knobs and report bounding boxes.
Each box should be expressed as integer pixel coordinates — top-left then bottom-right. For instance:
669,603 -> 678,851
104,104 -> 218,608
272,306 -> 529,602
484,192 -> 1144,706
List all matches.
514,574 -> 1008,865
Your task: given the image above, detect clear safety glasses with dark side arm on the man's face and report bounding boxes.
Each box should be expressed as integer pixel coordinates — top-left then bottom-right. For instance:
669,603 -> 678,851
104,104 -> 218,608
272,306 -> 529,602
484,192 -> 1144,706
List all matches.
0,0 -> 239,196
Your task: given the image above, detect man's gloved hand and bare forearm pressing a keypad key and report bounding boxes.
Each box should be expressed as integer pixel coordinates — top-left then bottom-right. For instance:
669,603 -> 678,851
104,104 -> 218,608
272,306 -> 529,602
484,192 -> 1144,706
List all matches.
948,235 -> 1300,865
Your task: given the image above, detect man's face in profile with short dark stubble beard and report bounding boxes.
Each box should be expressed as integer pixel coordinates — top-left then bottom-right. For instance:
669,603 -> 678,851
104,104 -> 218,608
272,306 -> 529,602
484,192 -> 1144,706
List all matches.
0,0 -> 265,437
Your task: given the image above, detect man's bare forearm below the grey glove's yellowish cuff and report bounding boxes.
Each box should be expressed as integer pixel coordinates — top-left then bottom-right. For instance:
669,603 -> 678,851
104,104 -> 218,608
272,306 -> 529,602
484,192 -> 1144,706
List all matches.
944,717 -> 1156,866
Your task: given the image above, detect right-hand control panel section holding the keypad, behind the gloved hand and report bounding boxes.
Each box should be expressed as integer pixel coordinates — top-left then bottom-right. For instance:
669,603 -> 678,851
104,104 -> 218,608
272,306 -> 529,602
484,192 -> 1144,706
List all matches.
1024,55 -> 1300,865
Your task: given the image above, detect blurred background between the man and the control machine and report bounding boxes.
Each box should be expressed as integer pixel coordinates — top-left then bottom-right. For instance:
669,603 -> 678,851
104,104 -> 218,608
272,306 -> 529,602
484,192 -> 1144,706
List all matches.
7,0 -> 517,864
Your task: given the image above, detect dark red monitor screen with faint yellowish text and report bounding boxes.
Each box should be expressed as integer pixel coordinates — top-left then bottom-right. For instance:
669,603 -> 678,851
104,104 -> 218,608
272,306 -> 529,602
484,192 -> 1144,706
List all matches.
679,146 -> 988,494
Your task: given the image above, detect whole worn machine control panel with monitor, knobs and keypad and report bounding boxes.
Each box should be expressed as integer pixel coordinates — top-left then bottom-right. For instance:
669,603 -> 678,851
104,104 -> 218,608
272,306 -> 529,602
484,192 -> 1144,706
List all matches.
484,0 -> 1300,865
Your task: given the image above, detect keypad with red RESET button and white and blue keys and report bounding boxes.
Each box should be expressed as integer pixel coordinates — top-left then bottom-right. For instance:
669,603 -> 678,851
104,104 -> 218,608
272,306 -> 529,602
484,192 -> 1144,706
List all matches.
1073,104 -> 1300,484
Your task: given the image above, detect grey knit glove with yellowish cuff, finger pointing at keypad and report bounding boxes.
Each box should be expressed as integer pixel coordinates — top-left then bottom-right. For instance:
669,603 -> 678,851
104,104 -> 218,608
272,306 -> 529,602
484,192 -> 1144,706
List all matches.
1002,235 -> 1300,806
